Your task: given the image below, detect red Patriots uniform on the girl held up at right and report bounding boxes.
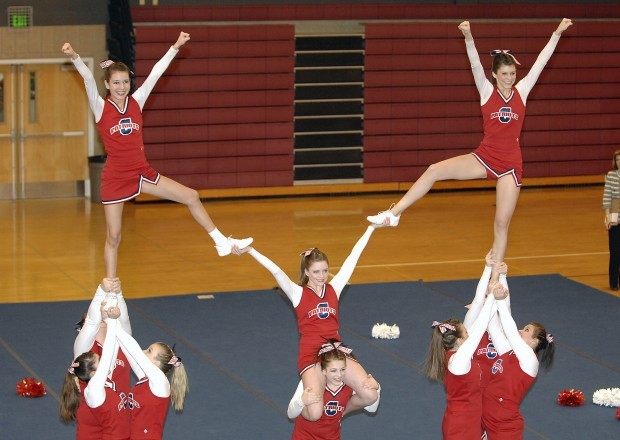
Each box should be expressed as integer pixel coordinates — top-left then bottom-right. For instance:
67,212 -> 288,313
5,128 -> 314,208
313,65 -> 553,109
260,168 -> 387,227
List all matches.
472,87 -> 525,186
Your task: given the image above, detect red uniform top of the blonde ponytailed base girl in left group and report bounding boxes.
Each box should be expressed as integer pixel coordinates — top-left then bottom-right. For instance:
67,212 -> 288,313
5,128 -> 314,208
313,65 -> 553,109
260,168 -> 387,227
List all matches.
128,377 -> 170,440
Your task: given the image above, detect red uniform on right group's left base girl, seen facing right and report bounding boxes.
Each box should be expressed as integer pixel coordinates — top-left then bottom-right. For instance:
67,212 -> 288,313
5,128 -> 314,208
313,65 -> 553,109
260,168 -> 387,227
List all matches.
441,351 -> 482,440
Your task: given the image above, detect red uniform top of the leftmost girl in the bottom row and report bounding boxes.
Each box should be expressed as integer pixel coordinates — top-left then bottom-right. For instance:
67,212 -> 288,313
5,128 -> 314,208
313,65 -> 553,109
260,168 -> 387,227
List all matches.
76,381 -> 129,440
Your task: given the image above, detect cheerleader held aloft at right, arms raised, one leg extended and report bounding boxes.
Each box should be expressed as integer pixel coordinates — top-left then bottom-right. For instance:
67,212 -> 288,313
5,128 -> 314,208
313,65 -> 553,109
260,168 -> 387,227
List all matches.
368,18 -> 573,283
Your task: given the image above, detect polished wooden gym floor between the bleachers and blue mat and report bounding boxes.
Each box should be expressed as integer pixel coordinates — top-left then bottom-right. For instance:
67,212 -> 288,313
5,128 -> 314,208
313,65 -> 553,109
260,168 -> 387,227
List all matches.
0,184 -> 612,302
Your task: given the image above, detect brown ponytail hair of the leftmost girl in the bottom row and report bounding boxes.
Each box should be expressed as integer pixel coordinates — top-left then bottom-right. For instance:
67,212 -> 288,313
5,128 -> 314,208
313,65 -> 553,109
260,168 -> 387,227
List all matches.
59,351 -> 99,423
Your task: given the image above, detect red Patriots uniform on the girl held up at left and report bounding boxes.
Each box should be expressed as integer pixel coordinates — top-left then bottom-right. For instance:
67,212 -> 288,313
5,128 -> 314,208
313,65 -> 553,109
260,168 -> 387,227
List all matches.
97,96 -> 159,204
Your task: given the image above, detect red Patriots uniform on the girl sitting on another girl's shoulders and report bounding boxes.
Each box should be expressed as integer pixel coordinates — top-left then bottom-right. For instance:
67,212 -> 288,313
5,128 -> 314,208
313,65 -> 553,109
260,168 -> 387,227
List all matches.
295,284 -> 340,374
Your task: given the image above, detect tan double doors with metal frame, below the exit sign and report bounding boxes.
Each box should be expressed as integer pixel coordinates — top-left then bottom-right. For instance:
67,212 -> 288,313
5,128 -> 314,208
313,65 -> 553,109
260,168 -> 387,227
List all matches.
0,59 -> 93,200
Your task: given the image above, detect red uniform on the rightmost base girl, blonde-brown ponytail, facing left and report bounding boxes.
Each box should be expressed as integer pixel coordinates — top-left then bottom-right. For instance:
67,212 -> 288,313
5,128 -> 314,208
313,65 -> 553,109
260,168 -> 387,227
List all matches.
482,351 -> 536,440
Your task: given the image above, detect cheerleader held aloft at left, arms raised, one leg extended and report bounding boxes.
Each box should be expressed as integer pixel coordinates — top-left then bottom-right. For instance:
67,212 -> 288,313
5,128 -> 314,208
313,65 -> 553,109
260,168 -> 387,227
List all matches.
62,32 -> 252,278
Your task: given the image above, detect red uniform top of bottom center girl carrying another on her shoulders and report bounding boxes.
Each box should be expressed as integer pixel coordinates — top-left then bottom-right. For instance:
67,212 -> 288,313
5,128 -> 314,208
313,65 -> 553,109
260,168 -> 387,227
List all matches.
292,383 -> 353,440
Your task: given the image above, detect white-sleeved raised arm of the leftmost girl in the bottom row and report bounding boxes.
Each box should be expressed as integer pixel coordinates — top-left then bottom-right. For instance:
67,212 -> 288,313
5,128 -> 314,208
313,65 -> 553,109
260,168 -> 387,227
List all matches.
84,307 -> 119,408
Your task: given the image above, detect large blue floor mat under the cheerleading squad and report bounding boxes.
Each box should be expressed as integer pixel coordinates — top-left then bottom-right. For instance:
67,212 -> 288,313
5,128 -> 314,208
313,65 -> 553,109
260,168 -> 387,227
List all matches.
0,275 -> 620,440
